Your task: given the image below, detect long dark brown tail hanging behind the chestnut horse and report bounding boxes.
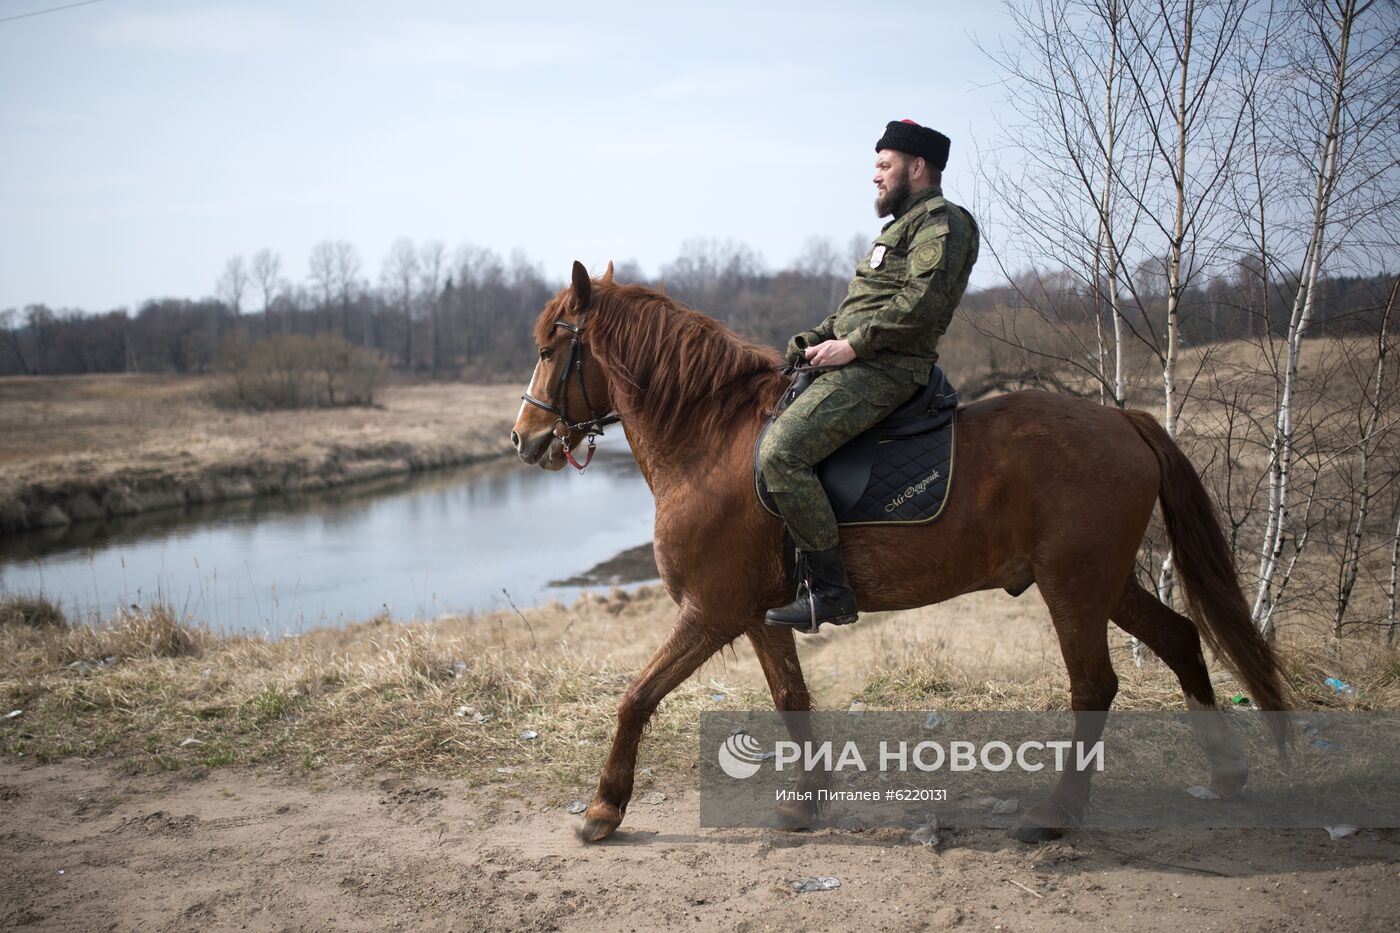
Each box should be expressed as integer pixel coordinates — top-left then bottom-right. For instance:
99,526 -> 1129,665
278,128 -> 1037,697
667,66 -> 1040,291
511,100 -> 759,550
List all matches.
1123,410 -> 1288,751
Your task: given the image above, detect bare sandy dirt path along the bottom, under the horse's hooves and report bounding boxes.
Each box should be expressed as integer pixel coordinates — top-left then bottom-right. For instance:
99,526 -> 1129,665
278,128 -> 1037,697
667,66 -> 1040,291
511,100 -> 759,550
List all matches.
0,761 -> 1400,932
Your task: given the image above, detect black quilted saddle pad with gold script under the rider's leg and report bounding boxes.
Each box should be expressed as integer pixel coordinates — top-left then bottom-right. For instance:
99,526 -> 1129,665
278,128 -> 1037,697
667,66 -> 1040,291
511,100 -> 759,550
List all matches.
753,366 -> 958,525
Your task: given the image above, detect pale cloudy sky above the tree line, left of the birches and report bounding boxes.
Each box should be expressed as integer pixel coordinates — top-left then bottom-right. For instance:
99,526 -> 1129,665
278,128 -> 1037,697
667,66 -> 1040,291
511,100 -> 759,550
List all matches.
0,0 -> 1005,311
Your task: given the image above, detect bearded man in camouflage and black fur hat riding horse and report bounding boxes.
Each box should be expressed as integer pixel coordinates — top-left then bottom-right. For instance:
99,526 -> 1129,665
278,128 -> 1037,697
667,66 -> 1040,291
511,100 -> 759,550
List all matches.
759,120 -> 979,632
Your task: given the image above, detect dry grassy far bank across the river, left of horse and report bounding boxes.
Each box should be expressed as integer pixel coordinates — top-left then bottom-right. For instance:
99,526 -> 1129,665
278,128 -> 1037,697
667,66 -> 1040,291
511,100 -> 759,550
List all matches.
0,374 -> 519,534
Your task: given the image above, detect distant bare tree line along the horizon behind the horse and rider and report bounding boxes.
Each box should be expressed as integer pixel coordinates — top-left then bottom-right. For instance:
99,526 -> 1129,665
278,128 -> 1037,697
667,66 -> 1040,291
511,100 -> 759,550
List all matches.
0,237 -> 1387,378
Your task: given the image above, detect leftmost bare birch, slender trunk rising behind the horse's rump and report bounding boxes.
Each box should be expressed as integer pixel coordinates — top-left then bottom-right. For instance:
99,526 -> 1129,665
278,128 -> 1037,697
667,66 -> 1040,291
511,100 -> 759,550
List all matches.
983,0 -> 1156,408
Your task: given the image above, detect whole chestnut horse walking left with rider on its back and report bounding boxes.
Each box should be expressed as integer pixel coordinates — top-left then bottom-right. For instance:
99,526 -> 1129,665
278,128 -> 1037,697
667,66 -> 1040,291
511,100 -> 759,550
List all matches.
511,262 -> 1284,842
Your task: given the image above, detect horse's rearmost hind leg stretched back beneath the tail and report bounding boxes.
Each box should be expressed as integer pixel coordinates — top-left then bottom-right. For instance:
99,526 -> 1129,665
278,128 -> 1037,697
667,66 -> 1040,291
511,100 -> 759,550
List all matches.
1109,577 -> 1249,797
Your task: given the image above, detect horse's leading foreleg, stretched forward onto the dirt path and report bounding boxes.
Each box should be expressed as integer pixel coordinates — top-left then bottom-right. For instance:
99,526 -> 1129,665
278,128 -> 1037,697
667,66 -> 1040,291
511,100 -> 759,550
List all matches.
580,609 -> 732,842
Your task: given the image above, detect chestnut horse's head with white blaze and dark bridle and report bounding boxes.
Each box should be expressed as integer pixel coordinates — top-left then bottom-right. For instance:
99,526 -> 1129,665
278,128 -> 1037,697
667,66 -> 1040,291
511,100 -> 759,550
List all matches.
511,262 -> 613,469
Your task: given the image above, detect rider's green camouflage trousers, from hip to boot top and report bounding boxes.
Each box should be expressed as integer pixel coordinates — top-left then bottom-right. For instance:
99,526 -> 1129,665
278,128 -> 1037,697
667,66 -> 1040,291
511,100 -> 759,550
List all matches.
759,360 -> 918,552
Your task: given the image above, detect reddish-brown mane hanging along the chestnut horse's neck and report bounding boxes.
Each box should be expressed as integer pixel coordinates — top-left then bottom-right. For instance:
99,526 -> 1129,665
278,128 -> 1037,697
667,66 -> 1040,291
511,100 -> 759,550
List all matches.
546,282 -> 785,445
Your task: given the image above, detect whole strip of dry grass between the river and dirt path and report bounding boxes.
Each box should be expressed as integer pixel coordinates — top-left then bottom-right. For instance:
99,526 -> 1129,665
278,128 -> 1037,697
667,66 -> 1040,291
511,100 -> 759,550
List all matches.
0,588 -> 1400,793
